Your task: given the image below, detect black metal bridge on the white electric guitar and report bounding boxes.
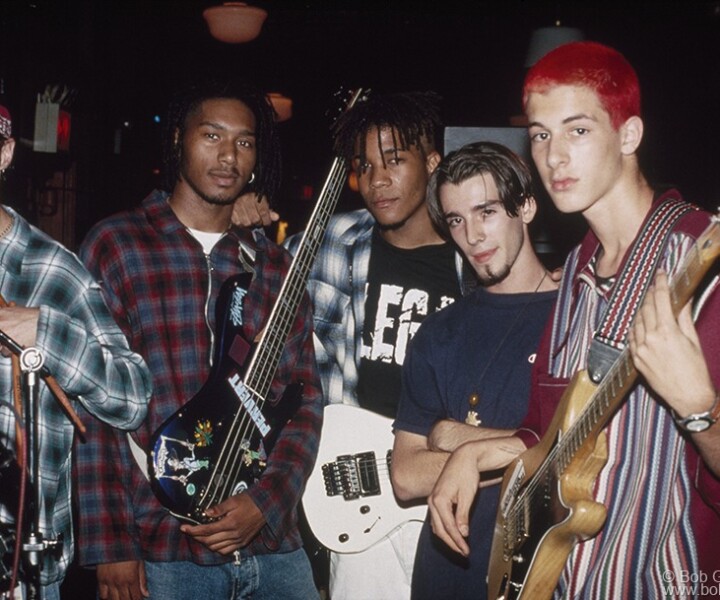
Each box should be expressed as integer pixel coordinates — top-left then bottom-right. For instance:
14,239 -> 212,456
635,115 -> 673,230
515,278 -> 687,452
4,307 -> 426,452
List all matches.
322,452 -> 381,500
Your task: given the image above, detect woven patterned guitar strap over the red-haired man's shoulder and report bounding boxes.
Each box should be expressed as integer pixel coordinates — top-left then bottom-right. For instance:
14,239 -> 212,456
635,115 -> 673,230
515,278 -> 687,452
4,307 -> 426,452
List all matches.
587,197 -> 696,383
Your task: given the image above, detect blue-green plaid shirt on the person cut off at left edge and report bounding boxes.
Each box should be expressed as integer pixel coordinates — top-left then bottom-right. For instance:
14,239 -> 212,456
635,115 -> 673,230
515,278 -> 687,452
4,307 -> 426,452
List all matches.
0,207 -> 151,584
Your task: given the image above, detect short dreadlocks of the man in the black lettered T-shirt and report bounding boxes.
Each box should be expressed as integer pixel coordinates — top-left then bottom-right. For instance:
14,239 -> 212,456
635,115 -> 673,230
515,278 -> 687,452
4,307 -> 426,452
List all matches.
332,92 -> 442,164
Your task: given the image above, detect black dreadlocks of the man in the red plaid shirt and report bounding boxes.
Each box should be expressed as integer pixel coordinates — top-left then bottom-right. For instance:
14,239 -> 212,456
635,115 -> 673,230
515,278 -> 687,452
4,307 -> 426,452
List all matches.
163,79 -> 281,200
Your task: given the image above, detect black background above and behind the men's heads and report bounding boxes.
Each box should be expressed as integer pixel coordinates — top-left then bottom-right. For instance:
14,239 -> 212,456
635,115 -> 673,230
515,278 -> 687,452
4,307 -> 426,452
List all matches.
0,0 -> 720,241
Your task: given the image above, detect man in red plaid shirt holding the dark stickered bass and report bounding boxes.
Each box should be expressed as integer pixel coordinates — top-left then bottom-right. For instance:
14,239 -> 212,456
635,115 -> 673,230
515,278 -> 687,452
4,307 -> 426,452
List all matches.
78,81 -> 322,600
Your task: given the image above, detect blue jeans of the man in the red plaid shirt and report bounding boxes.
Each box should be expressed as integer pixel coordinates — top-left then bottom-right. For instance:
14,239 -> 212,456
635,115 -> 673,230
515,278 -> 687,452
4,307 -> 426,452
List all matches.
145,548 -> 319,600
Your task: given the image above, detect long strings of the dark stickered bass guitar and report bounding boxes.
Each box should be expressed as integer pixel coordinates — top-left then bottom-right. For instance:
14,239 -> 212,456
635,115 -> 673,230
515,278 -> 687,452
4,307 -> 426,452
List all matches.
204,159 -> 345,508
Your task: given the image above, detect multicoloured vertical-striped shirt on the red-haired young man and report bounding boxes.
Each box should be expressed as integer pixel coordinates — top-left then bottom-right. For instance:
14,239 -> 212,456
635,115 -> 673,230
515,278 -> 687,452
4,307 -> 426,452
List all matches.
523,193 -> 720,600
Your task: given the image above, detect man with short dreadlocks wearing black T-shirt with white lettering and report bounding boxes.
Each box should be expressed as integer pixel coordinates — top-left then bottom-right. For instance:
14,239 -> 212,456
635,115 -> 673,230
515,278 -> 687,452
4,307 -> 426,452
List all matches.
236,92 -> 476,600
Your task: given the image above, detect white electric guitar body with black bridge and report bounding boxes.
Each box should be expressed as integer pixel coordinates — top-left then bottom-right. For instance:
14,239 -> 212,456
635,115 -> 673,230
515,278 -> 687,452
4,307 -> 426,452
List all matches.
302,404 -> 427,553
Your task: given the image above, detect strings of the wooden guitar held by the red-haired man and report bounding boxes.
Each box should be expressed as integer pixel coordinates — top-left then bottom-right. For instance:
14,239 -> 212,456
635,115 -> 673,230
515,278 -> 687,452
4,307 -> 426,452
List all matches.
508,244 -> 702,531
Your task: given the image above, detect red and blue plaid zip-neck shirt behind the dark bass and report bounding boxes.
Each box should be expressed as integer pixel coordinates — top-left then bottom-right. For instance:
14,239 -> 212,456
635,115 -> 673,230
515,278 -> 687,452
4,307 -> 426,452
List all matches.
77,191 -> 322,565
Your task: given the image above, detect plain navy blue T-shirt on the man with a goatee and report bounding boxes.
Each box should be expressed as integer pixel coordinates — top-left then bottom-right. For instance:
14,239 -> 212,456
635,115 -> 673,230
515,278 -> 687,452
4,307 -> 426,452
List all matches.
394,288 -> 557,600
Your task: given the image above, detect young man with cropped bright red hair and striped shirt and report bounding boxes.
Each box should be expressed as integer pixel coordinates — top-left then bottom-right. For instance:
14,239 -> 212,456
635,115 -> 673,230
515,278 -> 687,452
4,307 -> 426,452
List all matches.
429,42 -> 720,598
